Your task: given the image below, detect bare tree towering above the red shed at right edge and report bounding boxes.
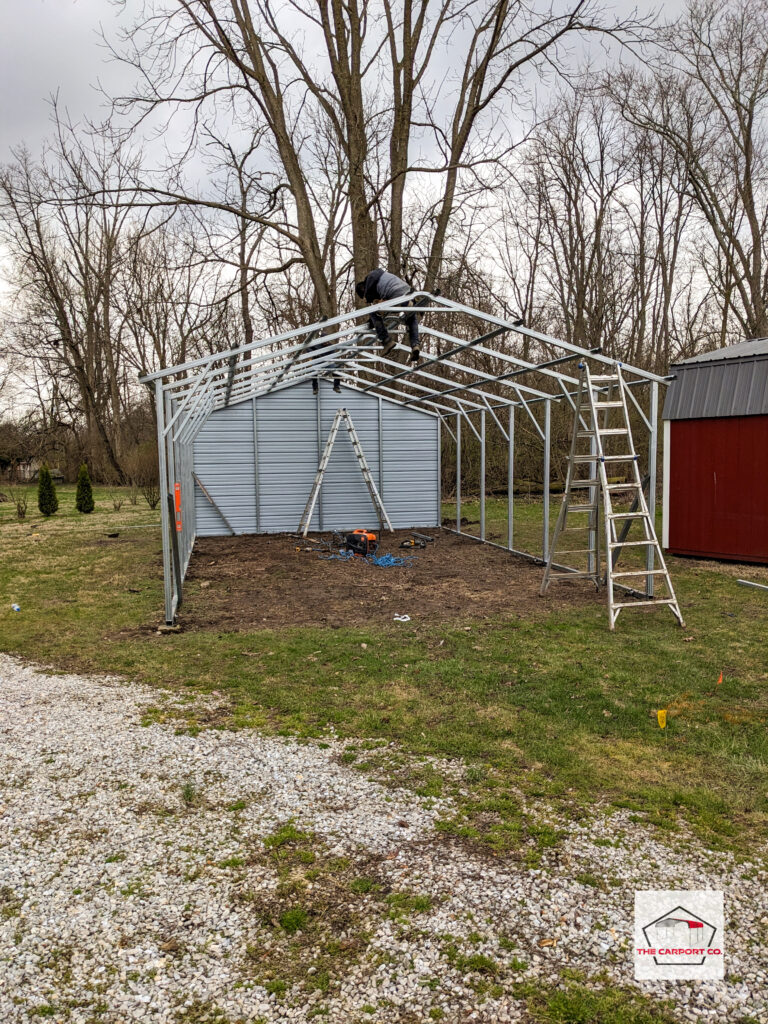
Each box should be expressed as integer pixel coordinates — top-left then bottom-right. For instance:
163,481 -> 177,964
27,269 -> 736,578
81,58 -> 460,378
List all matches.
610,0 -> 768,338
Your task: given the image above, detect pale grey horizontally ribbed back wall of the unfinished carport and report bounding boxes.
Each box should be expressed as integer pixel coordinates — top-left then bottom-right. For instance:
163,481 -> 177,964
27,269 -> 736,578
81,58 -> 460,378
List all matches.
195,381 -> 440,536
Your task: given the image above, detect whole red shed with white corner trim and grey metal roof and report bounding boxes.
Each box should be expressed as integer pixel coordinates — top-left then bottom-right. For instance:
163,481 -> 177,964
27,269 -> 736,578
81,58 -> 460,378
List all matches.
663,339 -> 768,563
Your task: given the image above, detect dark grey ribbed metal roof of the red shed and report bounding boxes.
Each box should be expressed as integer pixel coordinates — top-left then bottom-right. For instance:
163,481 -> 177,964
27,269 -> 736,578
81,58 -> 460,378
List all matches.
662,338 -> 768,420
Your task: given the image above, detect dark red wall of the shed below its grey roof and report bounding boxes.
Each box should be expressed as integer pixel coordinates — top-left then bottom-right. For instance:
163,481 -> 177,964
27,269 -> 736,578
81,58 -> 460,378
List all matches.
668,416 -> 768,562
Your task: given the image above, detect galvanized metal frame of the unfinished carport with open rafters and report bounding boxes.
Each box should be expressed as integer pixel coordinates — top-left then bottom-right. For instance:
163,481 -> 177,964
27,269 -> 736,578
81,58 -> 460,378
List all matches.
140,292 -> 668,623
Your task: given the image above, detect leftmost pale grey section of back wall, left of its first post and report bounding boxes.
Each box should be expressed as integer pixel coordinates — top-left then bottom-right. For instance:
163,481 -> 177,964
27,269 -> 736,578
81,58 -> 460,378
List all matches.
195,401 -> 258,537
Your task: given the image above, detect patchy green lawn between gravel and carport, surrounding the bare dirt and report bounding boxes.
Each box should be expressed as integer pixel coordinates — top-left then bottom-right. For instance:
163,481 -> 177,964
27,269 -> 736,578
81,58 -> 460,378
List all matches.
0,486 -> 768,861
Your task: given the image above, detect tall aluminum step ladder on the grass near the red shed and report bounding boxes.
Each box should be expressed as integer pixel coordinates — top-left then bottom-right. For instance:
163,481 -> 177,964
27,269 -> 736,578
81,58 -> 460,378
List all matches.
541,364 -> 684,630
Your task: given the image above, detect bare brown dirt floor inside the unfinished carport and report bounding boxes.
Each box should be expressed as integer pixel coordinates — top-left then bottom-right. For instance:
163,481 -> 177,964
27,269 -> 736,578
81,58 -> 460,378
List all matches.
179,529 -> 604,631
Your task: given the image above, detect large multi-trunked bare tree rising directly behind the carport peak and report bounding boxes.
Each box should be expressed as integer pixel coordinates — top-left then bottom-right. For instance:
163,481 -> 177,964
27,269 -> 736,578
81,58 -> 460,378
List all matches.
108,0 -> 644,316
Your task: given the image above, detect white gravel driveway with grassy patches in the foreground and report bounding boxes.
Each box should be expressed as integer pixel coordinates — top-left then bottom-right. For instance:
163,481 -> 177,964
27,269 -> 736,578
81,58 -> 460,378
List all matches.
0,655 -> 768,1024
